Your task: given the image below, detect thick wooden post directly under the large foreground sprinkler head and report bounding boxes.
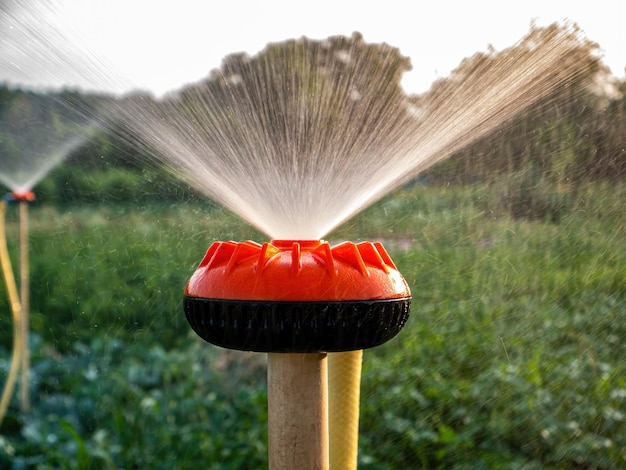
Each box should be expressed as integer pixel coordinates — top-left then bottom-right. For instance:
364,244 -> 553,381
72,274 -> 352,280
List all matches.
267,353 -> 328,470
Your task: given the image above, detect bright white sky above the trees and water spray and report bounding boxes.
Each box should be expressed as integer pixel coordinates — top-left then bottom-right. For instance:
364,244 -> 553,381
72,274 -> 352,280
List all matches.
0,0 -> 626,95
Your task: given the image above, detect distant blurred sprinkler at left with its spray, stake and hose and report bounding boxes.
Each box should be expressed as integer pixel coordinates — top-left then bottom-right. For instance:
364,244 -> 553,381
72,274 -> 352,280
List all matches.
0,82 -> 98,422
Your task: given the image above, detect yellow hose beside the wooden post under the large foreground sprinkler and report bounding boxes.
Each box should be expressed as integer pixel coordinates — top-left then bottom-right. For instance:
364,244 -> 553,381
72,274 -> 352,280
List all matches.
328,350 -> 363,470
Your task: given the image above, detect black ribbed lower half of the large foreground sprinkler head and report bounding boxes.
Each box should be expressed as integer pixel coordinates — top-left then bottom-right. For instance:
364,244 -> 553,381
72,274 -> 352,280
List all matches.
184,297 -> 411,353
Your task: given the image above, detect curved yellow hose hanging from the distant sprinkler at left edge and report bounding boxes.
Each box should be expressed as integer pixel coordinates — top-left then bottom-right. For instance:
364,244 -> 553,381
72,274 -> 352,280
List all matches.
0,200 -> 23,430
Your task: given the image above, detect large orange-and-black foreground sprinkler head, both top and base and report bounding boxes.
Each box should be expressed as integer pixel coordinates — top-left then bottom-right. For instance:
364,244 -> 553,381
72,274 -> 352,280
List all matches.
184,240 -> 411,353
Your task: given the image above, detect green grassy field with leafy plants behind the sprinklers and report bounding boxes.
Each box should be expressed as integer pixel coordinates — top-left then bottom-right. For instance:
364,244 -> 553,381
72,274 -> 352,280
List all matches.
0,183 -> 626,470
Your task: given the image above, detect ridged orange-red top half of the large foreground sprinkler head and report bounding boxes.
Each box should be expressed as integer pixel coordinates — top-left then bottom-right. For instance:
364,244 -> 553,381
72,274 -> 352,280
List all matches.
185,240 -> 410,302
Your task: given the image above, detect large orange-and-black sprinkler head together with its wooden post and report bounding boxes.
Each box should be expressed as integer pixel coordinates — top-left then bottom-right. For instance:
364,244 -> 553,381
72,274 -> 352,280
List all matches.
184,240 -> 411,469
